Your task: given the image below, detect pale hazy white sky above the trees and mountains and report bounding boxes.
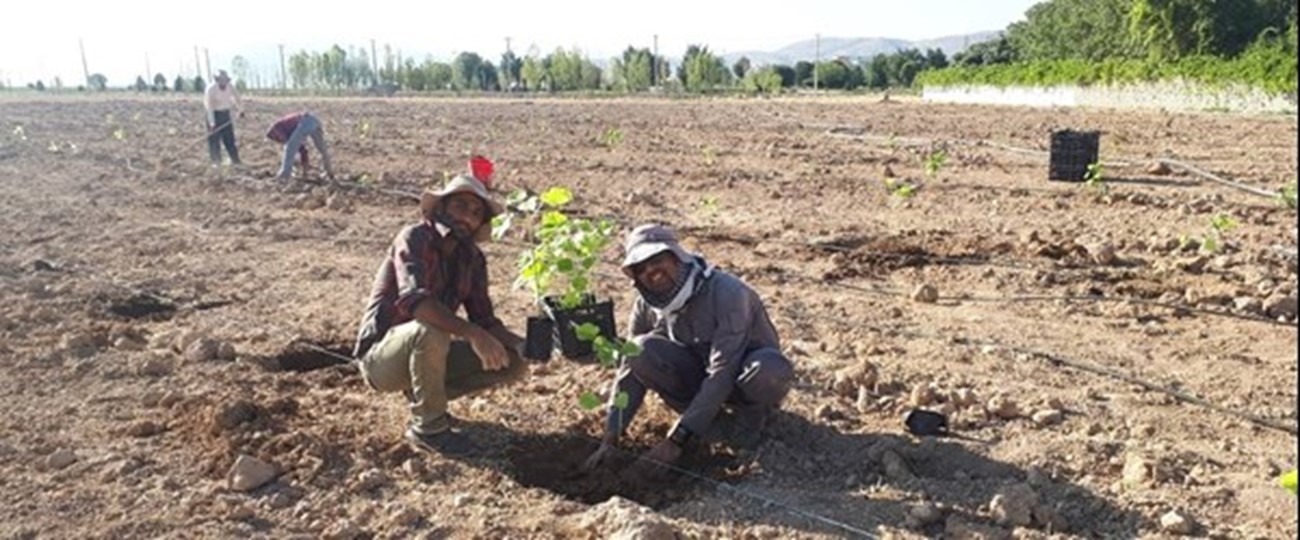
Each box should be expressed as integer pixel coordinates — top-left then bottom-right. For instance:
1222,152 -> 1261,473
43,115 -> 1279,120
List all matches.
0,0 -> 1039,86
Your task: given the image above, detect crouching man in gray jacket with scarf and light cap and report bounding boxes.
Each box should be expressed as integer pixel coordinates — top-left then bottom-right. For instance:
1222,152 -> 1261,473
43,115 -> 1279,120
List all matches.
584,224 -> 794,470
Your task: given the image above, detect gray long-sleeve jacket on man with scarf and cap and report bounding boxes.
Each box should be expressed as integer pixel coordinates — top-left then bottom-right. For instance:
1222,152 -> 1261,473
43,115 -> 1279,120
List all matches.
607,265 -> 780,435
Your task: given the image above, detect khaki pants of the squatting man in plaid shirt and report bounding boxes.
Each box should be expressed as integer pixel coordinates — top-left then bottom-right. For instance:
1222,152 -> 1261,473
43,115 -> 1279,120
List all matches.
361,320 -> 528,433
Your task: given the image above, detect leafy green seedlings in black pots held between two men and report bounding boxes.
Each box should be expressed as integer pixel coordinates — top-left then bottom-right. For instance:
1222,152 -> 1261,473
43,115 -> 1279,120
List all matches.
493,187 -> 615,360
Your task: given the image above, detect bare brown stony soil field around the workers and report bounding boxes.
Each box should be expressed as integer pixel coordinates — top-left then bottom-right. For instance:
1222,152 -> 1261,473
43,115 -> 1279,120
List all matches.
0,98 -> 1297,539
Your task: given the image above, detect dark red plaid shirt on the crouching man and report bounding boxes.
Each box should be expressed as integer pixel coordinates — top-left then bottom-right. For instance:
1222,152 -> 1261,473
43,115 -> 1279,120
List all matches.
352,221 -> 502,358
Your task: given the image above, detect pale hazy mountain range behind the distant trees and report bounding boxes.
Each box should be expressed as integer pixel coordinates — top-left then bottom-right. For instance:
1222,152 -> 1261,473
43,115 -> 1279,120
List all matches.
723,31 -> 1000,65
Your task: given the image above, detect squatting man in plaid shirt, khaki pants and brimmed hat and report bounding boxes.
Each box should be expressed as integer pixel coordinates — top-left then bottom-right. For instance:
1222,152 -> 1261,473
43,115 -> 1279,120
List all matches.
354,176 -> 528,455
